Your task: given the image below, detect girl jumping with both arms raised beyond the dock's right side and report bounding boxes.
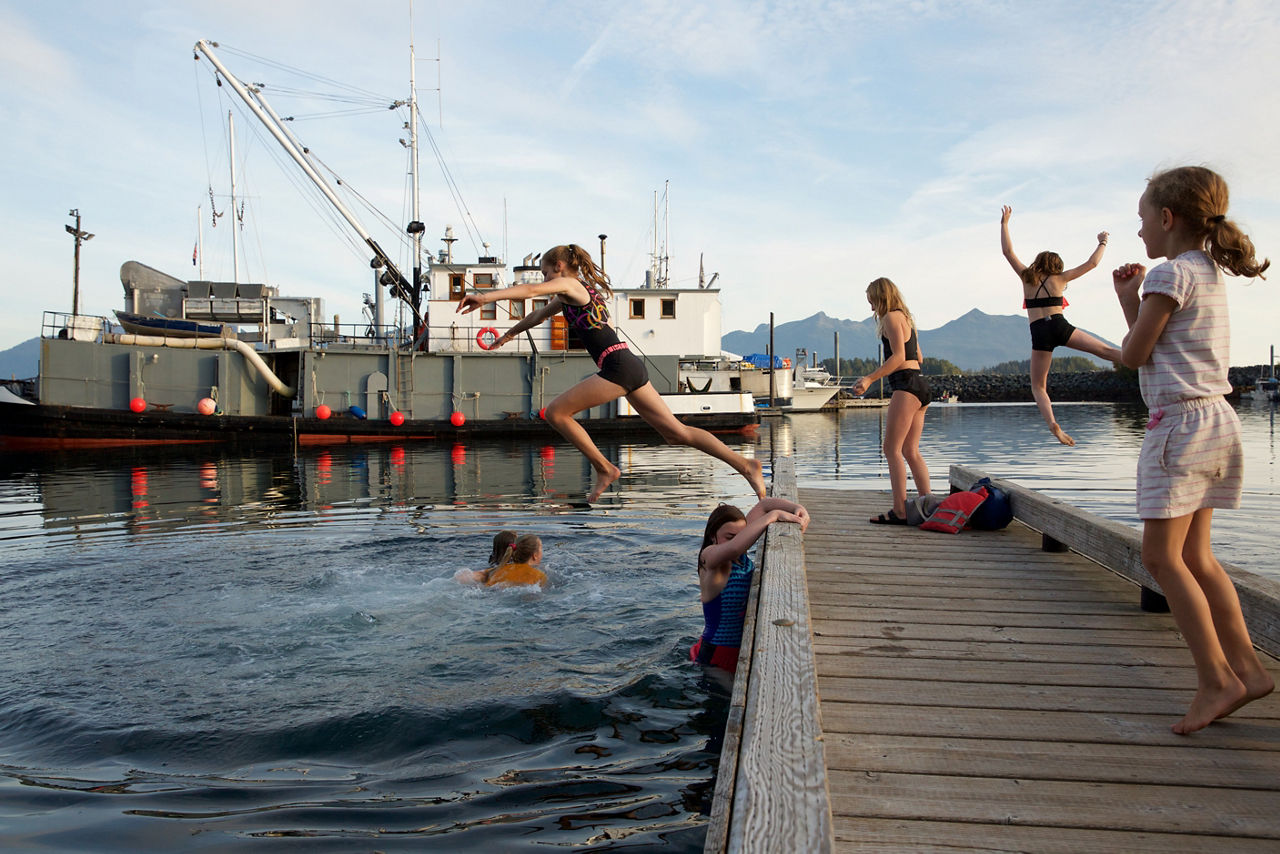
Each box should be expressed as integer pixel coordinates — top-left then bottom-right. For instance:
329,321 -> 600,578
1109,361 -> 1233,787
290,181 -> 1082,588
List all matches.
1000,205 -> 1120,446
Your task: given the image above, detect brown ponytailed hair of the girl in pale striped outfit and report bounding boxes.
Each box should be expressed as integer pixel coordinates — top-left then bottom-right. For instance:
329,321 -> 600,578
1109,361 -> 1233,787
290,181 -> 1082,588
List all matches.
1144,166 -> 1271,279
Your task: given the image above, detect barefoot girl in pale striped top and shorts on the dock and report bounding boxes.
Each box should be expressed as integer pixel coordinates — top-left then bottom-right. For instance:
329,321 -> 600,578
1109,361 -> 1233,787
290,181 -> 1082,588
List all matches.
1112,166 -> 1275,735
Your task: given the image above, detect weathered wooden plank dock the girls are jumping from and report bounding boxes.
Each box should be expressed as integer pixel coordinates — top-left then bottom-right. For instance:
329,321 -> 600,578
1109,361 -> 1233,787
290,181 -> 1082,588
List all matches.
707,466 -> 1280,854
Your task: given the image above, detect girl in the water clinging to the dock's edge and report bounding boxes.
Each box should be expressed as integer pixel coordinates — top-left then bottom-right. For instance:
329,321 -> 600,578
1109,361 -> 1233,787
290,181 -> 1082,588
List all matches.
689,498 -> 809,673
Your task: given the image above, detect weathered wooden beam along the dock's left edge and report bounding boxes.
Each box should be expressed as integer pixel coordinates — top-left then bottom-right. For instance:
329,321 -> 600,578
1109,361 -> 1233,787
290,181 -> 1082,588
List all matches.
704,457 -> 833,854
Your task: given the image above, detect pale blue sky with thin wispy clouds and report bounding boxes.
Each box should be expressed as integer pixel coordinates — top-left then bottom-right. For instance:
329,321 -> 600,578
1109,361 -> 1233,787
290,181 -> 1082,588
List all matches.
0,0 -> 1280,365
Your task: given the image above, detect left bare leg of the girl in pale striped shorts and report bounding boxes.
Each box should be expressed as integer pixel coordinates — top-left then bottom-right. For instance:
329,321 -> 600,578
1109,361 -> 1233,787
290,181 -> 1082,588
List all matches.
1142,511 -> 1247,735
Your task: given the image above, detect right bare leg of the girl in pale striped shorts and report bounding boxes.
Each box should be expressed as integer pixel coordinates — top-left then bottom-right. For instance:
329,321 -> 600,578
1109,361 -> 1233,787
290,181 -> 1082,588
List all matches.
1183,508 -> 1276,717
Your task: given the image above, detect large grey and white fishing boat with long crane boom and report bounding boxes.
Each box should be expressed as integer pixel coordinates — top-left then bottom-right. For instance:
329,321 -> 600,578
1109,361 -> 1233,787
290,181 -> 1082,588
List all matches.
0,41 -> 759,451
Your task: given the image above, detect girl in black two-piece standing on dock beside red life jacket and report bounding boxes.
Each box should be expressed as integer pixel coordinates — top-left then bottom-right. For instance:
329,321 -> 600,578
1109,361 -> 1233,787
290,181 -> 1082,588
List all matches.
854,277 -> 933,525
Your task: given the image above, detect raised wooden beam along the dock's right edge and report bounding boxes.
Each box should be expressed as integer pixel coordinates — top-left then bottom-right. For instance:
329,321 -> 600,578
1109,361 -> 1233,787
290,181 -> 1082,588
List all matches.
951,466 -> 1280,657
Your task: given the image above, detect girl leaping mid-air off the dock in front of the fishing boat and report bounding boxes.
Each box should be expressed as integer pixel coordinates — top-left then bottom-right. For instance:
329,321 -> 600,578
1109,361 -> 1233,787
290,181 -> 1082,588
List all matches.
457,243 -> 764,501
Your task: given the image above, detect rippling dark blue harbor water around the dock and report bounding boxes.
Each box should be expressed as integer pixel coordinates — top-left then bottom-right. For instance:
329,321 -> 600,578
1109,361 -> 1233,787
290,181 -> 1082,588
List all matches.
0,405 -> 1280,851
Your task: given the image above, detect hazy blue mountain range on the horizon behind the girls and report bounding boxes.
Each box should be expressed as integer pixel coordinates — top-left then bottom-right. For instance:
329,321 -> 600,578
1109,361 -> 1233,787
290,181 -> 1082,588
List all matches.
721,309 -> 1110,371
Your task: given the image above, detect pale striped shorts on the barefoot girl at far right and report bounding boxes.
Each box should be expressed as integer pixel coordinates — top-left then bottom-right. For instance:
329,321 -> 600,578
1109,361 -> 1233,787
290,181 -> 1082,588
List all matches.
1138,397 -> 1244,519
